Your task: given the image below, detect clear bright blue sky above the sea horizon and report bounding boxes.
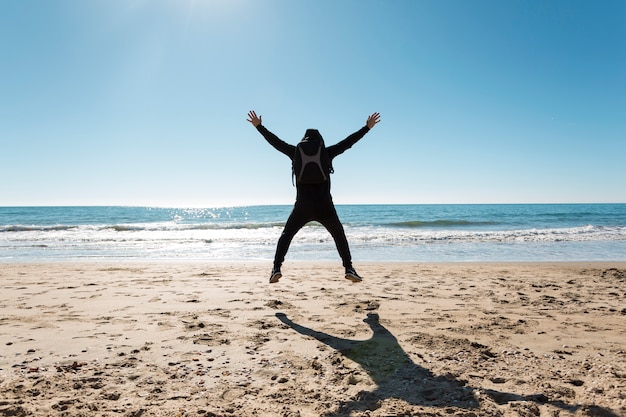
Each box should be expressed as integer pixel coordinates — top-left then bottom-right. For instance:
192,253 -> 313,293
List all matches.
0,0 -> 626,207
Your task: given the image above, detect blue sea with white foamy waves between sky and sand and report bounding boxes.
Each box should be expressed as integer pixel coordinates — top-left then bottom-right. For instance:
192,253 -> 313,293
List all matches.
0,204 -> 626,262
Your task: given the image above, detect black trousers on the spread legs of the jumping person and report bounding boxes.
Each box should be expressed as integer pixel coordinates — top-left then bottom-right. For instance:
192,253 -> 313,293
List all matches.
274,200 -> 352,268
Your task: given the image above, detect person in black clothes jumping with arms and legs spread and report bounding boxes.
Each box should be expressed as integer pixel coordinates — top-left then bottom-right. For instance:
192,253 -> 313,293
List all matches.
247,110 -> 380,284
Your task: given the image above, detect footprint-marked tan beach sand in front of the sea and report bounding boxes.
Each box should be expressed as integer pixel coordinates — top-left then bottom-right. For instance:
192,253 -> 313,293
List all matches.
0,262 -> 626,417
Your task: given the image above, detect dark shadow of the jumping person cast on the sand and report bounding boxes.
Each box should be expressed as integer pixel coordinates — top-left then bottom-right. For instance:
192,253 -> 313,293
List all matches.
276,312 -> 619,417
